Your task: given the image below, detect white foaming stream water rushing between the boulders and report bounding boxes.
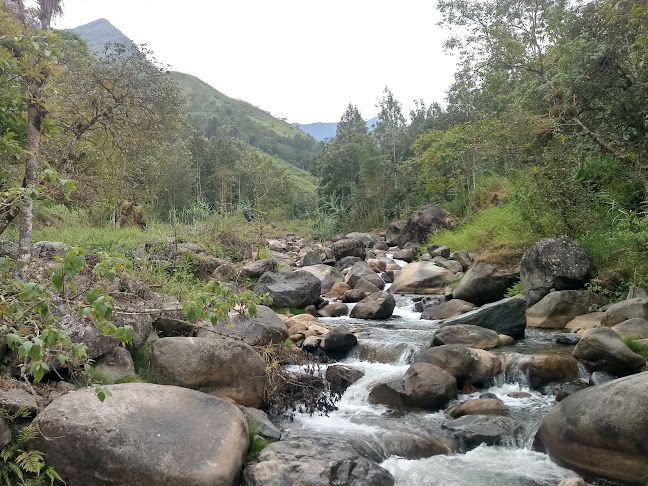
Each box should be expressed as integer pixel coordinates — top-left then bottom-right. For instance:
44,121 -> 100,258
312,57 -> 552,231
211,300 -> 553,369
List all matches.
281,296 -> 624,486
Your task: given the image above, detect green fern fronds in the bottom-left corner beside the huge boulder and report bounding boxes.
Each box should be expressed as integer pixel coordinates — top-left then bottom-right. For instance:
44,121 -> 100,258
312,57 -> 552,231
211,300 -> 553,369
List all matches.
0,425 -> 64,486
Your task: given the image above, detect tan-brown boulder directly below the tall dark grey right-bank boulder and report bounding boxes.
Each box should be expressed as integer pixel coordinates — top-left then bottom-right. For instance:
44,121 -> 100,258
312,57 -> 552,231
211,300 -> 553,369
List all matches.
526,290 -> 606,329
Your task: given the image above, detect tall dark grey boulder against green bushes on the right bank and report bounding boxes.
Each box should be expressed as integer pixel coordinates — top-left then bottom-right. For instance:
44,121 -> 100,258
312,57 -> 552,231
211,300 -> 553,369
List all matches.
520,236 -> 597,305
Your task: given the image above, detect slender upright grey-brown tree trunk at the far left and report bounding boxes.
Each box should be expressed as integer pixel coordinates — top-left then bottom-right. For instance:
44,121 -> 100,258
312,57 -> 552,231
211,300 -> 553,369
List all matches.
18,100 -> 45,277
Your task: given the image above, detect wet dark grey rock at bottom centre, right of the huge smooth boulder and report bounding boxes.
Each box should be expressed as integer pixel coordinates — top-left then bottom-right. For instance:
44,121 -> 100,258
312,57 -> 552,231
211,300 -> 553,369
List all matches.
242,438 -> 394,486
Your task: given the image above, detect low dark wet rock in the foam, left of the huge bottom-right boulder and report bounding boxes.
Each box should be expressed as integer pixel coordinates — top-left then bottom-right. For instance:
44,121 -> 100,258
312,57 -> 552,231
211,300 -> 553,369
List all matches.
443,415 -> 523,449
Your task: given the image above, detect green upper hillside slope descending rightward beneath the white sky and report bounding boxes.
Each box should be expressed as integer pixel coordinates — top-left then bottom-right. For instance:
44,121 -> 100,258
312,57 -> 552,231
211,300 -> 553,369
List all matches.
169,72 -> 317,169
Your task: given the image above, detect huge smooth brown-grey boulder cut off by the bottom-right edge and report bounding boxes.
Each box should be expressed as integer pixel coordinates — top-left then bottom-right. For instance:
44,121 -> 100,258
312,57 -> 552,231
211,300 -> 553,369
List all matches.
534,373 -> 648,484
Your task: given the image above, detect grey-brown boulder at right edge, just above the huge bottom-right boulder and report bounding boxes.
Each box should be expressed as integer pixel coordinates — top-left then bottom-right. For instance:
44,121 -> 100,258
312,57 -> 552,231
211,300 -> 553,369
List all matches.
573,327 -> 646,376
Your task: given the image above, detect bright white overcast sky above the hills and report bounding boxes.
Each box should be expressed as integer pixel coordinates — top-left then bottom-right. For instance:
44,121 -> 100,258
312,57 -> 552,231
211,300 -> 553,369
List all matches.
56,0 -> 455,123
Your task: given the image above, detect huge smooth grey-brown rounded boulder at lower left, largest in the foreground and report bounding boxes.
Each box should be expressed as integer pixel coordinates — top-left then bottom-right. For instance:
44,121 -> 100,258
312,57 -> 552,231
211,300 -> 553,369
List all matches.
29,383 -> 249,486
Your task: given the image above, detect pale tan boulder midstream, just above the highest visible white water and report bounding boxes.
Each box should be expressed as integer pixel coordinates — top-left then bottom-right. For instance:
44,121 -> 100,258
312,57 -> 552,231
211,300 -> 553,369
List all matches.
389,262 -> 455,294
